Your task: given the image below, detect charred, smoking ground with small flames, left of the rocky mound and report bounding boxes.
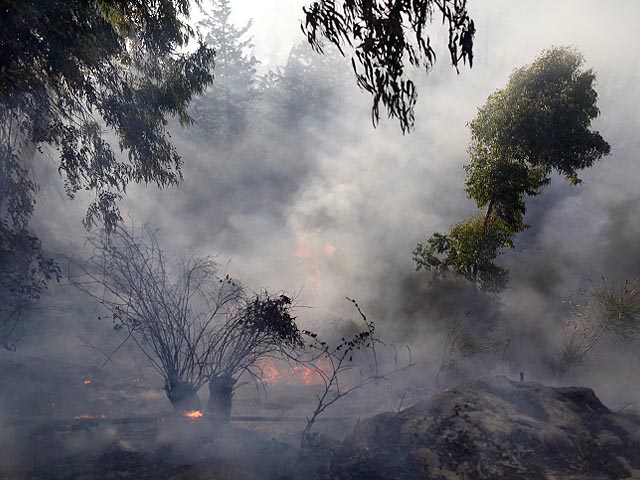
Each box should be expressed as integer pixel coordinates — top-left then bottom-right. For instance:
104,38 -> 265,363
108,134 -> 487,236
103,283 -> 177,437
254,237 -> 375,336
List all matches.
0,350 -> 410,479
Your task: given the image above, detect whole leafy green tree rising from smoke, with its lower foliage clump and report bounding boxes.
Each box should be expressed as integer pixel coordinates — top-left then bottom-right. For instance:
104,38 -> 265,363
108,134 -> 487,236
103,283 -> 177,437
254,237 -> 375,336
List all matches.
413,48 -> 610,291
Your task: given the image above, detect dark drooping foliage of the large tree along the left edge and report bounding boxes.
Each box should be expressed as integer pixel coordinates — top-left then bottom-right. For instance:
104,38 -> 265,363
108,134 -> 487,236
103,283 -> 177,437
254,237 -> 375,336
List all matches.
0,0 -> 213,347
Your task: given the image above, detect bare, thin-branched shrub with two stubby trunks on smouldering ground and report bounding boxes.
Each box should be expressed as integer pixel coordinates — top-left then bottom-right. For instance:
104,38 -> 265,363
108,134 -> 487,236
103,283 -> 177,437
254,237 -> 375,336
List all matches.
72,225 -> 300,420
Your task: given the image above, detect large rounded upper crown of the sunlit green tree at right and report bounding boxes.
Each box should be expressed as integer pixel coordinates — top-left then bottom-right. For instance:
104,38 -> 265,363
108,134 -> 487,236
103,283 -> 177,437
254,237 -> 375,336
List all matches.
465,48 -> 610,232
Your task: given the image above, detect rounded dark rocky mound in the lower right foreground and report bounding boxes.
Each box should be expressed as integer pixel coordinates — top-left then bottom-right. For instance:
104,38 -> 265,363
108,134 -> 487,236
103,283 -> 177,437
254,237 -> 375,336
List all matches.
334,377 -> 640,480
